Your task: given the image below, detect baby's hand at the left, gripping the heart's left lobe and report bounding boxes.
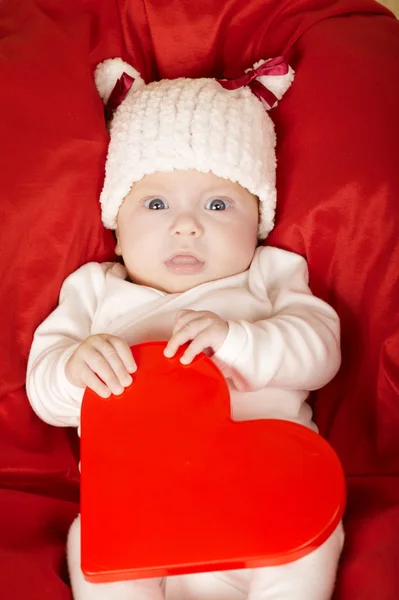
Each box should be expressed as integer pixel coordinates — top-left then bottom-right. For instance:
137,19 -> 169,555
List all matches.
65,334 -> 137,398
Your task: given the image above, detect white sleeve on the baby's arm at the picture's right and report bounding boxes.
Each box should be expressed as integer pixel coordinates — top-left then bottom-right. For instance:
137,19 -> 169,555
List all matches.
214,247 -> 341,392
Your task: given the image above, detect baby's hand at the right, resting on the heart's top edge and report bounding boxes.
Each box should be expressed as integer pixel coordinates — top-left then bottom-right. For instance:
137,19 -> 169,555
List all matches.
164,310 -> 229,365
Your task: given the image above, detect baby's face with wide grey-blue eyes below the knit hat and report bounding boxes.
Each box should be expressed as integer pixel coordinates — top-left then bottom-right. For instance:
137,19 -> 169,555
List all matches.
117,171 -> 259,293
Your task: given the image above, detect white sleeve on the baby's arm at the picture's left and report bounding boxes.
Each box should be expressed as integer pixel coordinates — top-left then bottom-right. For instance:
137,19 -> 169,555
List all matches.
26,263 -> 112,427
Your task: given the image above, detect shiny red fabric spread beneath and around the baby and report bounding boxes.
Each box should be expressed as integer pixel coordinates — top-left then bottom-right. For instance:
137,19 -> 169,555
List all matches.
0,0 -> 399,600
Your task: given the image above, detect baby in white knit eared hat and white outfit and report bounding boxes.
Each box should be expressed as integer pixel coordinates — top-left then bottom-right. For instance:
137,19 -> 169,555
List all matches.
27,58 -> 343,600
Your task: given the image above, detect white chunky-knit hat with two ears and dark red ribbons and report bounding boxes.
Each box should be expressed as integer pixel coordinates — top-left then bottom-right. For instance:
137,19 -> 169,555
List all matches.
95,57 -> 294,239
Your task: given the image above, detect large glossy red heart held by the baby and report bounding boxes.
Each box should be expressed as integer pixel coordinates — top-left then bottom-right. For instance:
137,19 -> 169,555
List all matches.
81,342 -> 345,582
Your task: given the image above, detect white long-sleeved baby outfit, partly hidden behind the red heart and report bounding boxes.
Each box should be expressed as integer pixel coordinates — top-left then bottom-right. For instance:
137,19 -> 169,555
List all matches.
27,247 -> 343,600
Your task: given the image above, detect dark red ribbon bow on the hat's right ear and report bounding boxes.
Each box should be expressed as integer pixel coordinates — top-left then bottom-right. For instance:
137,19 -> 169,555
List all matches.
216,56 -> 288,107
